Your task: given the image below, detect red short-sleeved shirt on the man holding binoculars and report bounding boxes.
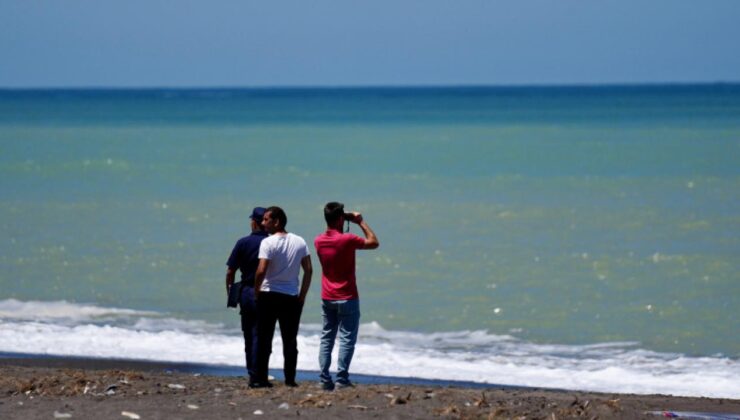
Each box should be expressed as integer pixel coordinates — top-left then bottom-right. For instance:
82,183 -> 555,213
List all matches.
313,229 -> 365,300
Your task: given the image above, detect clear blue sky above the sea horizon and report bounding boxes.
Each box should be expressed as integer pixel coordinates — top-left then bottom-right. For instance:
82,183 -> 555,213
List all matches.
0,0 -> 740,88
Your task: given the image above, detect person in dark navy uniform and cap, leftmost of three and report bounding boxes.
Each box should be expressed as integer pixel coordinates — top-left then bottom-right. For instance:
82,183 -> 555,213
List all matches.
226,207 -> 267,385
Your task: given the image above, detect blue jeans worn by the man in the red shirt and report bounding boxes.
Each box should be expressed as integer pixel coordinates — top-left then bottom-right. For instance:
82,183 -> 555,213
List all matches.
319,299 -> 360,383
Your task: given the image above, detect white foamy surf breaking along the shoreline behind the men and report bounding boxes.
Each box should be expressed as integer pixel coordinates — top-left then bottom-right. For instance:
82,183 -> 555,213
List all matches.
0,301 -> 740,398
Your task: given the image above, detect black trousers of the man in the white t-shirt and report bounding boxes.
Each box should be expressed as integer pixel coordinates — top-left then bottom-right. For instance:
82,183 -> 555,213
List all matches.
256,292 -> 303,383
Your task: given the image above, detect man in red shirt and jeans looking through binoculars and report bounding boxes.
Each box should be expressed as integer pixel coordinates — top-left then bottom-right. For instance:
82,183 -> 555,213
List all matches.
314,201 -> 380,390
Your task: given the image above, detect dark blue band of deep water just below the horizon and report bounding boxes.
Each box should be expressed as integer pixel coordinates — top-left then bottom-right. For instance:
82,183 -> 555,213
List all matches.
0,84 -> 740,126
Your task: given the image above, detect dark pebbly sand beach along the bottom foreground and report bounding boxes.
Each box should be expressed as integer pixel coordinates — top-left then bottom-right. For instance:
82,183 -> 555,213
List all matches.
0,358 -> 740,419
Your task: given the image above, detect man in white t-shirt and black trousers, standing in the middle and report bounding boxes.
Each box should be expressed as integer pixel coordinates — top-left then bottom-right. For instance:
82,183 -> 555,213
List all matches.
250,206 -> 313,388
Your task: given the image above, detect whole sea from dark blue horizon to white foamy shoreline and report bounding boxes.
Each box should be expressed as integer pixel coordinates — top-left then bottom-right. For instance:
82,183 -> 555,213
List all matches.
0,84 -> 740,398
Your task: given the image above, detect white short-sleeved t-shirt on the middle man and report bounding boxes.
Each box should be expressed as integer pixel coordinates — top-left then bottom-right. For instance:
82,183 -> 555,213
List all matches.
259,233 -> 309,296
